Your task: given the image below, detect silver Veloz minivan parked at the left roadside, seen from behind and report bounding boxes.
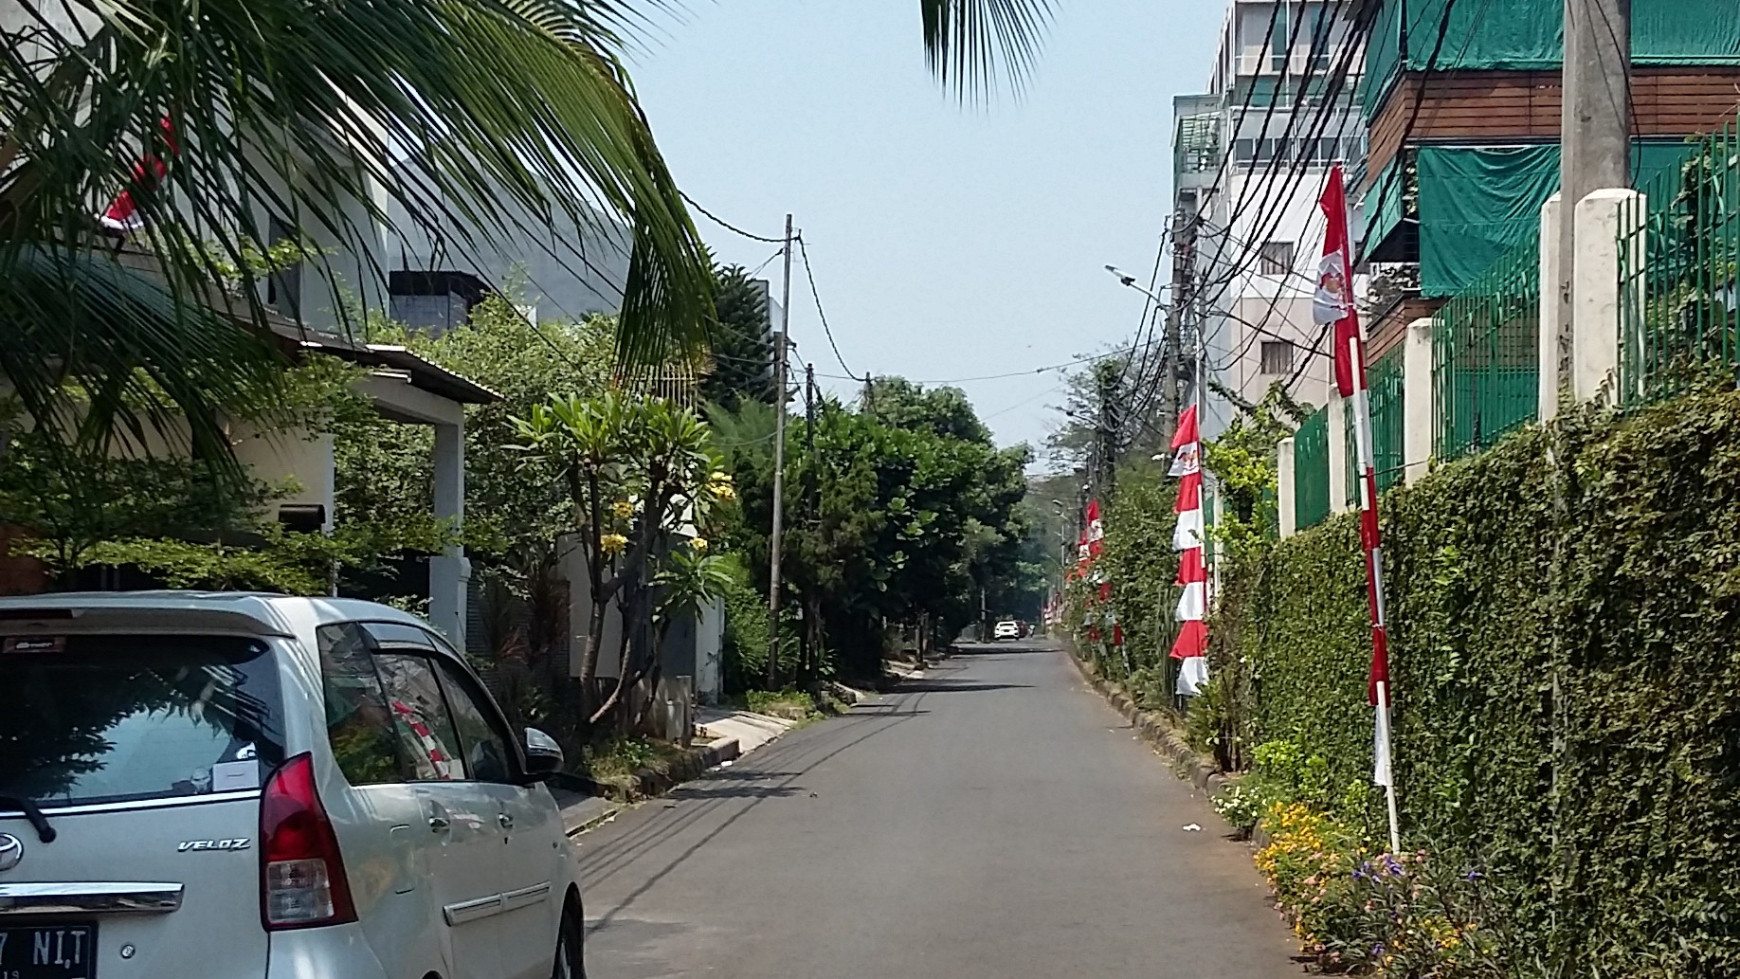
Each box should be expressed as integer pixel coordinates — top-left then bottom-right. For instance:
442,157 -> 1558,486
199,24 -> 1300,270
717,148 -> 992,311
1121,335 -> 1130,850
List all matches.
0,591 -> 585,979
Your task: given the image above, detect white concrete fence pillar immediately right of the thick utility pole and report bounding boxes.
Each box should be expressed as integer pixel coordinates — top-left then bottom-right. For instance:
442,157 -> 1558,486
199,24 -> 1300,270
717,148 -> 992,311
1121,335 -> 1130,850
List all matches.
1571,188 -> 1644,402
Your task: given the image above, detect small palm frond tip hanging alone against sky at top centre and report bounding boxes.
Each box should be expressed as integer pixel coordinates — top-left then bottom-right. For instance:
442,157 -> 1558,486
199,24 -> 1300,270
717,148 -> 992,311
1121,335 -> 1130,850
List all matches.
919,0 -> 1053,101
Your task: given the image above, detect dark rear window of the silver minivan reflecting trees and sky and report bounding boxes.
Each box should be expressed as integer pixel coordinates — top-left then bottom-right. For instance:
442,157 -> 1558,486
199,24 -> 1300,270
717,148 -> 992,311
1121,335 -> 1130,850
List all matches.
0,635 -> 284,809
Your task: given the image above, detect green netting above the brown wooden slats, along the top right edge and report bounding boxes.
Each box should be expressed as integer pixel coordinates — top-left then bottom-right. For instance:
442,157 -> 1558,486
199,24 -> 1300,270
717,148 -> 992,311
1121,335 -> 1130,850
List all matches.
1364,0 -> 1740,120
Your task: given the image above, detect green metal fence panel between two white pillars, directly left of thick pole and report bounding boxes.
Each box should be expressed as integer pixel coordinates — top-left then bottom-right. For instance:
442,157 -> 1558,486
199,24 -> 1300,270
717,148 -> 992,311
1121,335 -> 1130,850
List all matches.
1432,226 -> 1540,459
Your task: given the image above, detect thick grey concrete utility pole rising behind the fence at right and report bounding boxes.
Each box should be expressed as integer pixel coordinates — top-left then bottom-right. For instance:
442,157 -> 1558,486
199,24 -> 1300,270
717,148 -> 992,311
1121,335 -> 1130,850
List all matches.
1566,0 -> 1632,375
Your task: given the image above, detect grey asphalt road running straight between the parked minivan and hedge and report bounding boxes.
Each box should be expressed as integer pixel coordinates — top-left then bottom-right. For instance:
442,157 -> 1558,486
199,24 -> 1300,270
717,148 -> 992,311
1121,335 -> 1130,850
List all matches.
579,642 -> 1300,979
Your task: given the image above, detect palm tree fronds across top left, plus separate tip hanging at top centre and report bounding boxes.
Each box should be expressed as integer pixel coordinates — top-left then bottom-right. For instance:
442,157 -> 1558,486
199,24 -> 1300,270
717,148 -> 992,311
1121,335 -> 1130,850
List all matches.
0,0 -> 1049,459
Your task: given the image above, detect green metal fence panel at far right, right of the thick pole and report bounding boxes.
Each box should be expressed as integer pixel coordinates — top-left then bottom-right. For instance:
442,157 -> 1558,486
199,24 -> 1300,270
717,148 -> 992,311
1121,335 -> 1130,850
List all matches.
1618,123 -> 1740,407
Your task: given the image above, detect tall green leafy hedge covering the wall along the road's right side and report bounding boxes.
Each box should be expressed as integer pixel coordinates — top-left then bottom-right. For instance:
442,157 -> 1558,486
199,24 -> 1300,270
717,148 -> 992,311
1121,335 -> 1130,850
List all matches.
1221,393 -> 1740,979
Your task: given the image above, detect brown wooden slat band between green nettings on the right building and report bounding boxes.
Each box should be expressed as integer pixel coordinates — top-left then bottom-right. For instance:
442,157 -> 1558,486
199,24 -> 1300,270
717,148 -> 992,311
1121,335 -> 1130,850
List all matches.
1366,66 -> 1740,188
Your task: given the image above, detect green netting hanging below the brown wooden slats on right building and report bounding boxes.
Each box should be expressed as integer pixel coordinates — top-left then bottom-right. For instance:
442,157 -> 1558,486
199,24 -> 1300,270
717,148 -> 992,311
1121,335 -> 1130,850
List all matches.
1419,141 -> 1705,296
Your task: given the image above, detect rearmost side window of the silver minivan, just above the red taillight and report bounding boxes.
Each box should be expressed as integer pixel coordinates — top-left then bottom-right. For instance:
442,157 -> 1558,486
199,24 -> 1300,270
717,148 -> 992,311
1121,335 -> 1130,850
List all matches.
315,623 -> 405,786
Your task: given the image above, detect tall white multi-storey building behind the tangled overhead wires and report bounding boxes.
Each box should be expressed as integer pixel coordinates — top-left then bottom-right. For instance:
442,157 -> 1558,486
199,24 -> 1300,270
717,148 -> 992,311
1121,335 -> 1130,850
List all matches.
1173,0 -> 1364,436
